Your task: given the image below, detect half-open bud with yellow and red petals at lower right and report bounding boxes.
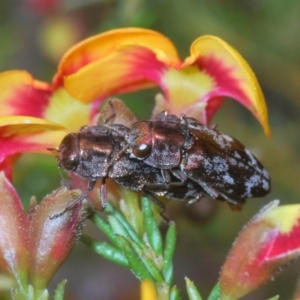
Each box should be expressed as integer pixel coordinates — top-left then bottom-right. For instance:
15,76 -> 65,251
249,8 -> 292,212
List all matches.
220,201 -> 300,300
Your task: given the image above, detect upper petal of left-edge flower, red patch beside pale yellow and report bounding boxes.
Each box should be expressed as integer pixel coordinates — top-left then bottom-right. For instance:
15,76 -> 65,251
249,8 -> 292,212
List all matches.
0,70 -> 94,131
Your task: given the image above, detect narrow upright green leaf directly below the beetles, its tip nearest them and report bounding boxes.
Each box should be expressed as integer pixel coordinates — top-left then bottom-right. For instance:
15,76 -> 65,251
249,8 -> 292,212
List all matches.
142,197 -> 163,255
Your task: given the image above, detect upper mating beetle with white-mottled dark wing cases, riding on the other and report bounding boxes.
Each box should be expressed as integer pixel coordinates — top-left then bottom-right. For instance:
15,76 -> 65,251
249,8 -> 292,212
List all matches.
124,111 -> 270,209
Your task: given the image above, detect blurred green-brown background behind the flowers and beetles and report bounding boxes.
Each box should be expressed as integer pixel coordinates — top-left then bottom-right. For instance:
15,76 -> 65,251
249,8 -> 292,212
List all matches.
0,0 -> 300,300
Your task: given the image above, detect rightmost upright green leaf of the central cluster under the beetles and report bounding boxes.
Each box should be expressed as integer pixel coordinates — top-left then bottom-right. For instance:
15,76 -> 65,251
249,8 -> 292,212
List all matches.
162,223 -> 176,285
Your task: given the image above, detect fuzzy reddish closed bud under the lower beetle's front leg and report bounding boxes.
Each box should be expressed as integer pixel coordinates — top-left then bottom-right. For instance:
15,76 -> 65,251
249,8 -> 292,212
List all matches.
29,188 -> 85,290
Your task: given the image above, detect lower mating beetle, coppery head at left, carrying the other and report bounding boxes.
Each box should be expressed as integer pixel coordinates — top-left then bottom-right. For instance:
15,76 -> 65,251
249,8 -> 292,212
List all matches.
56,124 -> 203,219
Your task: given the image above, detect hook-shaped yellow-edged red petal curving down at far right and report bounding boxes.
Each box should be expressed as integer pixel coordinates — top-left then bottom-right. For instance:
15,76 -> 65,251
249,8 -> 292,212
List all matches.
188,36 -> 270,136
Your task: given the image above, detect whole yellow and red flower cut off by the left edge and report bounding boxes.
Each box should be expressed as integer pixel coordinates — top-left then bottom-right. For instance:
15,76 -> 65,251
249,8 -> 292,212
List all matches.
0,70 -> 96,177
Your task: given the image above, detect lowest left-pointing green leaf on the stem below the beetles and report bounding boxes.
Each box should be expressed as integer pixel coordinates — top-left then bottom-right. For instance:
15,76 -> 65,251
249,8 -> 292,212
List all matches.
81,235 -> 129,268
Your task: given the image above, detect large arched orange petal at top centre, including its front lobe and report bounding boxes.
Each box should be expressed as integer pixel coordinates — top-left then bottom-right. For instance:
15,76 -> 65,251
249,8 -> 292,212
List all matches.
58,28 -> 180,102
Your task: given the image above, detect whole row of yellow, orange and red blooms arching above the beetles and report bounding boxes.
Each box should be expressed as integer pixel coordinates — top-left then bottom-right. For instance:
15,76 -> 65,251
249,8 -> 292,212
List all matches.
0,28 -> 270,175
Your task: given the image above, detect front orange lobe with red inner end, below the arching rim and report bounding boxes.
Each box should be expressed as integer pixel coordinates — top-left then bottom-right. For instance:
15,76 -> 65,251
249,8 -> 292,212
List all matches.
65,46 -> 165,102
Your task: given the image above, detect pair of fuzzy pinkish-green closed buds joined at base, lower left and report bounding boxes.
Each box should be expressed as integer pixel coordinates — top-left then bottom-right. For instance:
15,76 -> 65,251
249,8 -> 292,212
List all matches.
0,172 -> 85,299
